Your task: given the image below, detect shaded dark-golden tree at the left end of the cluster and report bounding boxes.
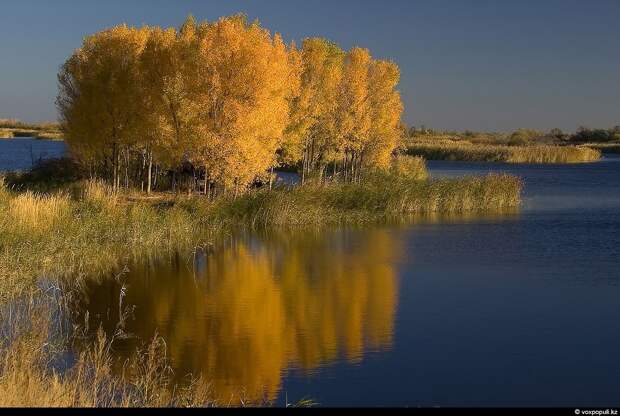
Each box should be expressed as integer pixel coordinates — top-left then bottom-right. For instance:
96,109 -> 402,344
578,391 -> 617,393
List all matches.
56,25 -> 148,188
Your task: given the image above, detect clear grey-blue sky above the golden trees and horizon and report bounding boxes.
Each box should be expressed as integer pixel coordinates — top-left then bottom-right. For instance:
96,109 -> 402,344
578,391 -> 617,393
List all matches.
0,0 -> 620,131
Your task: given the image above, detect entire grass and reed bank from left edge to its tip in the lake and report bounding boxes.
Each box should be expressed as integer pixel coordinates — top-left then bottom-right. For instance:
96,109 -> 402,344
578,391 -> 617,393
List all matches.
0,171 -> 521,299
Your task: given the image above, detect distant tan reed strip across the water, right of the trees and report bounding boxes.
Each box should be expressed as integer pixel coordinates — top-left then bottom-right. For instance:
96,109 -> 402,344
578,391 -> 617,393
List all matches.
407,141 -> 601,163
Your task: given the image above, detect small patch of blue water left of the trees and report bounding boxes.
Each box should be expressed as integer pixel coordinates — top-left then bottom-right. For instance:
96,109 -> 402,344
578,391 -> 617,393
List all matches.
0,137 -> 67,172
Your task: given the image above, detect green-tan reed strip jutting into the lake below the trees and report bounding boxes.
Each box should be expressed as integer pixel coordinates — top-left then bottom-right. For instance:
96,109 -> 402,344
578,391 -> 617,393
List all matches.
209,174 -> 522,226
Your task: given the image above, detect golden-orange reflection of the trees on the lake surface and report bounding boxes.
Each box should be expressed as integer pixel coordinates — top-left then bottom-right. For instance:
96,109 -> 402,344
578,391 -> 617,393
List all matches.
74,229 -> 402,400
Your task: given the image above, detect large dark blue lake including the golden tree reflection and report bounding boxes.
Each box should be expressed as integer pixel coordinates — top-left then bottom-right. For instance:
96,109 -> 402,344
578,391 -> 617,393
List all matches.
0,140 -> 620,407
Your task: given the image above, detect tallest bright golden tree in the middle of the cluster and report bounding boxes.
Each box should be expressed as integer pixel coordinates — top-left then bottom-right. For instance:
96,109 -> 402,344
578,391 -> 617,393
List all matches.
192,15 -> 290,194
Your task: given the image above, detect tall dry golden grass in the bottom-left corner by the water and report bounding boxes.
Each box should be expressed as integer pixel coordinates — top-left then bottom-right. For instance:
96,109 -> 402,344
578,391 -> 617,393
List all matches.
0,296 -> 246,407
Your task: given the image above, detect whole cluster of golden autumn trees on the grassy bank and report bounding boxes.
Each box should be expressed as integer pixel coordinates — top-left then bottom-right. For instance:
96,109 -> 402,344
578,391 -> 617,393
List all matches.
57,15 -> 402,195
